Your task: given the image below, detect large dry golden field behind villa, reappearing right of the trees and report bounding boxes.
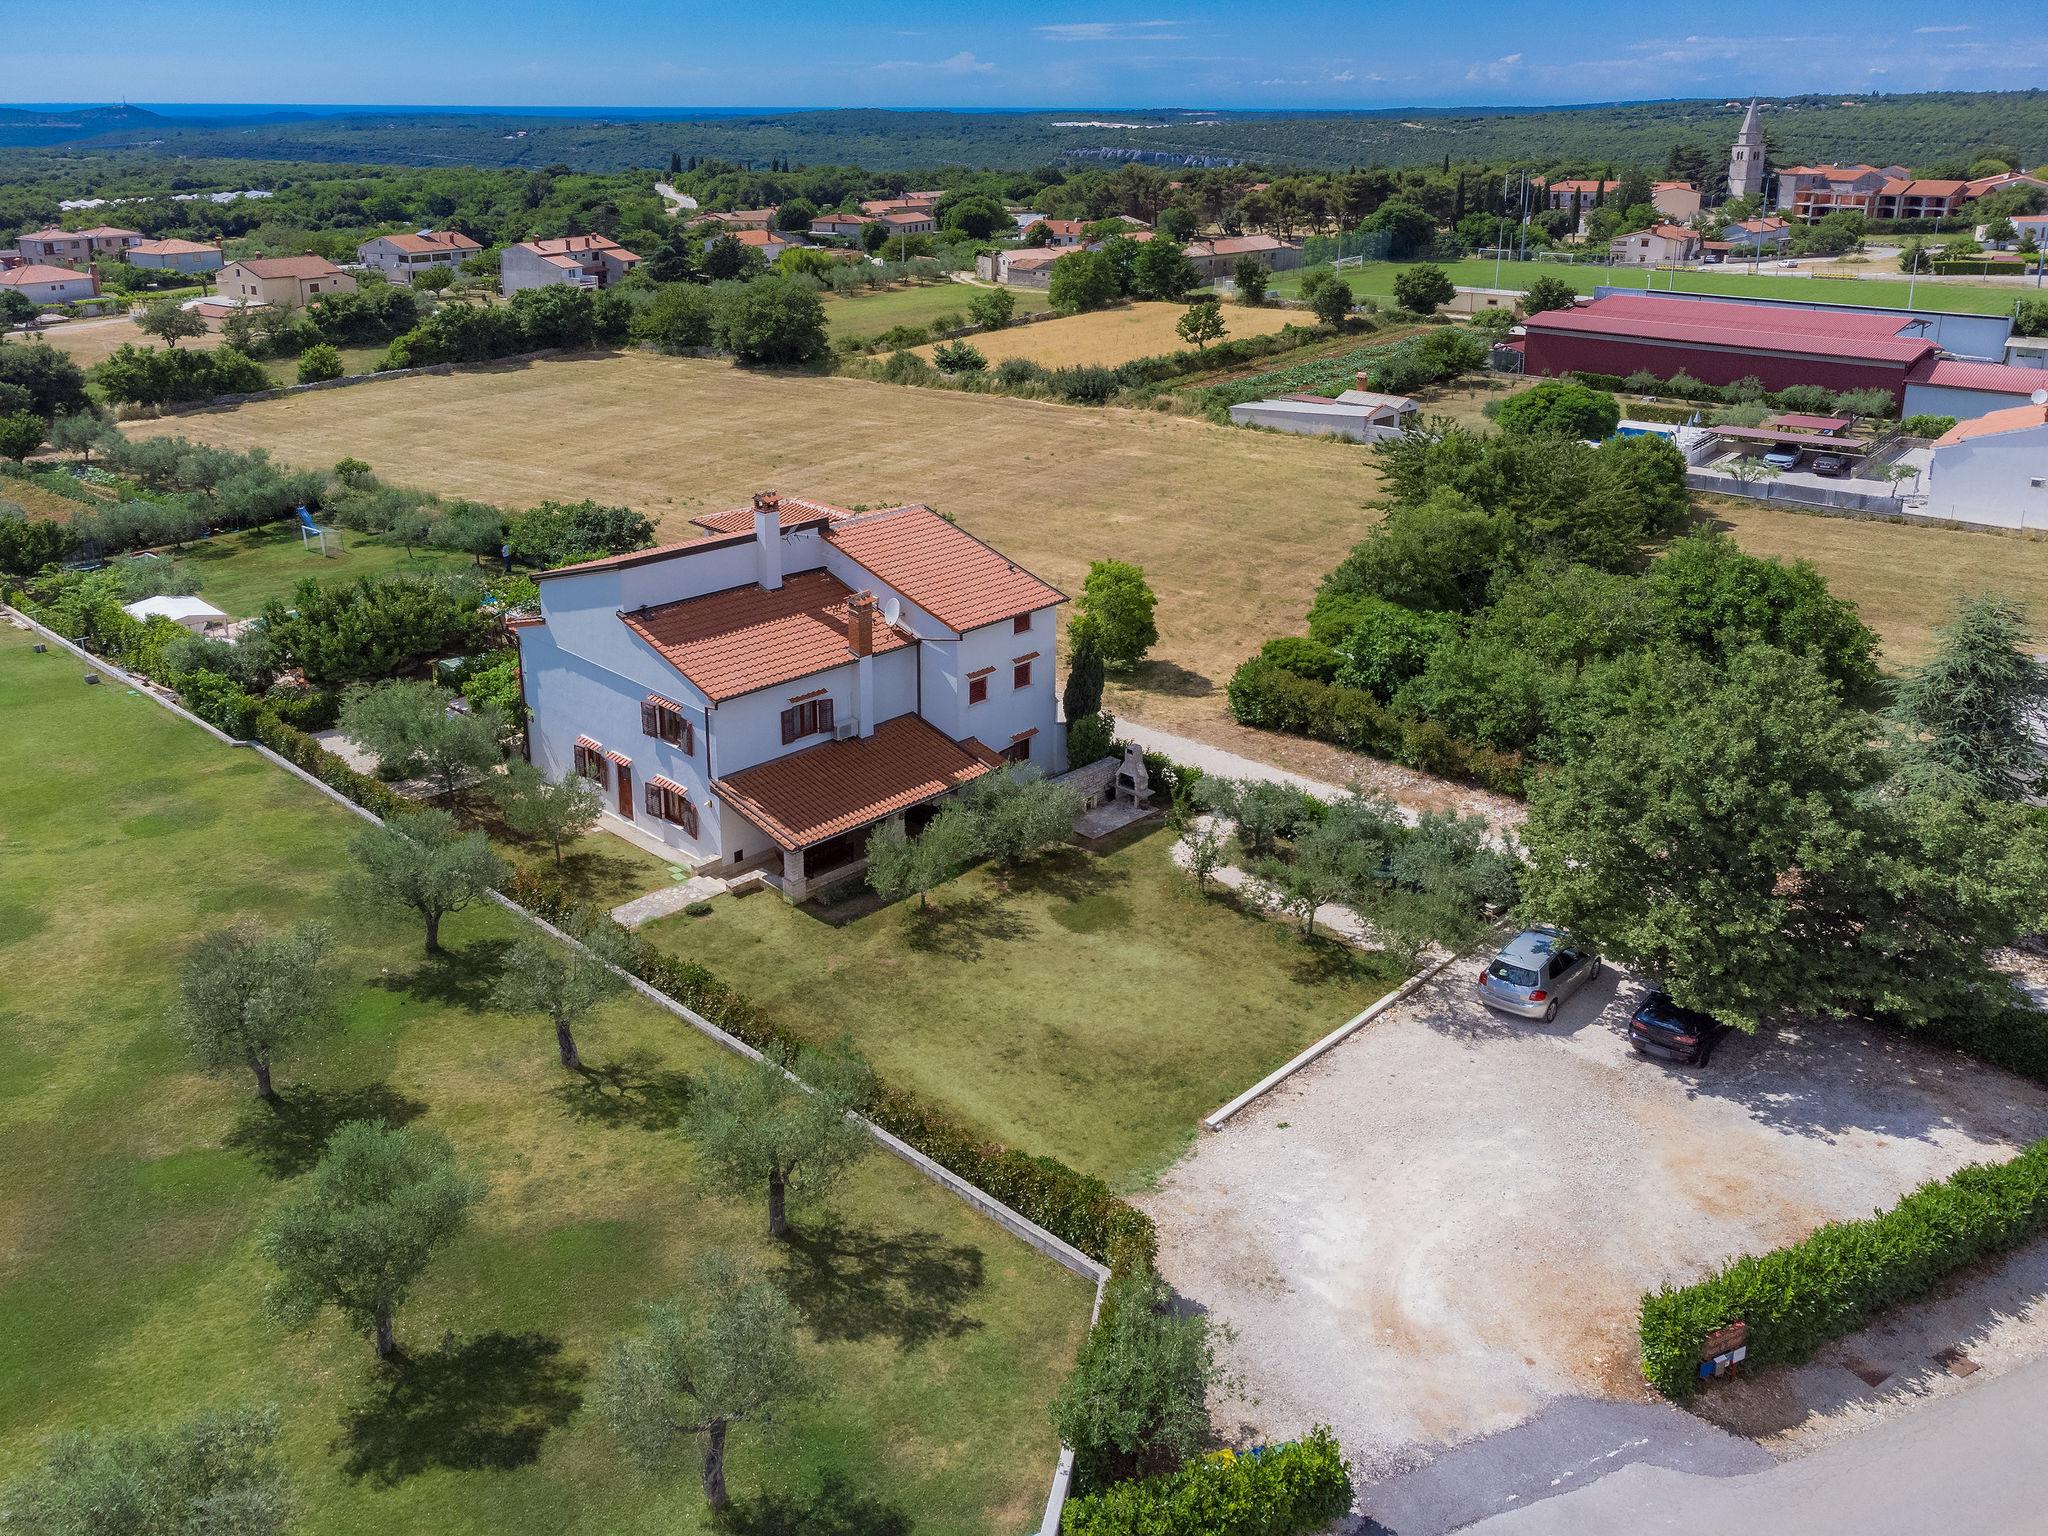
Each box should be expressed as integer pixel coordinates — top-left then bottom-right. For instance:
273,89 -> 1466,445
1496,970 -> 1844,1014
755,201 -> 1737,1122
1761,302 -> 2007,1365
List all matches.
129,352 -> 2048,735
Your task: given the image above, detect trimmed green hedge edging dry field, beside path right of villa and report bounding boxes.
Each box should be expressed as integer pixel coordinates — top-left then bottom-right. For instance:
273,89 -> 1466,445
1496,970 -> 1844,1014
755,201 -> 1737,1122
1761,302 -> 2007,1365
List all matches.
1225,655 -> 1524,795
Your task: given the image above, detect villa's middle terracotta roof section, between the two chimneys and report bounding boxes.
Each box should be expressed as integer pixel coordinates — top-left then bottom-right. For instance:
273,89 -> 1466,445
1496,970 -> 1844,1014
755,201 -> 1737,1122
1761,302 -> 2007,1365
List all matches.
618,571 -> 909,702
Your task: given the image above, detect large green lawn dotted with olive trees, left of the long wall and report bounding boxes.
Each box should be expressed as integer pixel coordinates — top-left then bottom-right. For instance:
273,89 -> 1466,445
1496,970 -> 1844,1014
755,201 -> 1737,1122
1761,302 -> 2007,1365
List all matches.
0,629 -> 1090,1536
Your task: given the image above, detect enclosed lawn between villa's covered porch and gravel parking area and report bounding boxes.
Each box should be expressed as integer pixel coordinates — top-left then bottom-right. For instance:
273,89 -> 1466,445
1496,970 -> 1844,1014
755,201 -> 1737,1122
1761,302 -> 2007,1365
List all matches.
641,829 -> 1393,1190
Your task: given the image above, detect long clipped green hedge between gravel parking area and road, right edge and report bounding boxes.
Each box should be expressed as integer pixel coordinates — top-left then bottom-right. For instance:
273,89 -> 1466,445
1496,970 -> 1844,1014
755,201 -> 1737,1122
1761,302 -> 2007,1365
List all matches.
1640,1139 -> 2048,1399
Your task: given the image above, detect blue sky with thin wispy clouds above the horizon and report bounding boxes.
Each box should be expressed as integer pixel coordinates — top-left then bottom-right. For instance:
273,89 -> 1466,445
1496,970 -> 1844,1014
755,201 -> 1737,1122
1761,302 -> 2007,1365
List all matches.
16,0 -> 2048,106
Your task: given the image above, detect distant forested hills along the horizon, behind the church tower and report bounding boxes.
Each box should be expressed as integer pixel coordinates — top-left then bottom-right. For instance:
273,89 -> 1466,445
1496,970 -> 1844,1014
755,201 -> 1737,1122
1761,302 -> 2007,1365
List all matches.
19,90 -> 2048,170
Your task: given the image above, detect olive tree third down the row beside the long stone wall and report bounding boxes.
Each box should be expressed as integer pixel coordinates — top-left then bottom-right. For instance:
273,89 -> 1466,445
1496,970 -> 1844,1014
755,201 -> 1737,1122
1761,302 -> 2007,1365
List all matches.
682,1042 -> 874,1237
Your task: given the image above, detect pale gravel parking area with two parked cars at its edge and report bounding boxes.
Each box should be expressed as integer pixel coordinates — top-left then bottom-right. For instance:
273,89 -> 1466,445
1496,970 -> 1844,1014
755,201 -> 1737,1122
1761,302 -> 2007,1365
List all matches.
1143,961 -> 2048,1479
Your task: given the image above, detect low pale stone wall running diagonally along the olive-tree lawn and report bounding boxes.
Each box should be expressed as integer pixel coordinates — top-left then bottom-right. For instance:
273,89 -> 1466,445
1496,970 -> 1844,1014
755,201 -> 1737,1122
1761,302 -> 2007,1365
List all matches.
0,606 -> 1110,1536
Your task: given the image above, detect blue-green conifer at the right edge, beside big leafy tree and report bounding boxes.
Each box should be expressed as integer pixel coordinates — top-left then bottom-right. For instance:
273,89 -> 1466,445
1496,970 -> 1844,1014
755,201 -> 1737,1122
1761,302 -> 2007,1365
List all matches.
1894,594 -> 2048,799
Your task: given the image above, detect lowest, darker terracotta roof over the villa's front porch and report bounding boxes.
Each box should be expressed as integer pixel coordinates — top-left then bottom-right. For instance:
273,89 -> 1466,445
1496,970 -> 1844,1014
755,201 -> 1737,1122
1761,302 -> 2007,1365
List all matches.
711,715 -> 1004,848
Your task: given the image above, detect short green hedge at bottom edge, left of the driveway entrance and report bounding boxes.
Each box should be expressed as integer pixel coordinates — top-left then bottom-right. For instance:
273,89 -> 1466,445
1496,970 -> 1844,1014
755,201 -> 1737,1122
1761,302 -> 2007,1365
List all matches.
1059,1423 -> 1352,1536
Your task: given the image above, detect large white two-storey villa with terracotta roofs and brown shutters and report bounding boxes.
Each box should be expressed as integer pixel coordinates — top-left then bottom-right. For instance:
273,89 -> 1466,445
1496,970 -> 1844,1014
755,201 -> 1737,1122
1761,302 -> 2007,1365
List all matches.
512,492 -> 1065,901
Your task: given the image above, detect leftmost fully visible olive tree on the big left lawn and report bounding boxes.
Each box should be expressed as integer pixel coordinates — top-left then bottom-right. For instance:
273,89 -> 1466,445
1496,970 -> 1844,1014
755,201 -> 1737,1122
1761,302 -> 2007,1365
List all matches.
178,922 -> 334,1104
